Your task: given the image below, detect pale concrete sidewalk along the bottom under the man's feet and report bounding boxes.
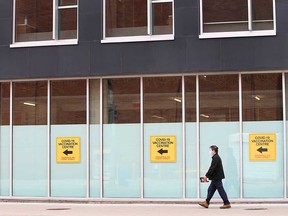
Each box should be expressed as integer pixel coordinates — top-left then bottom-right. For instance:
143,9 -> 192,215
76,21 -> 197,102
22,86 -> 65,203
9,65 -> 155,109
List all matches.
0,202 -> 288,216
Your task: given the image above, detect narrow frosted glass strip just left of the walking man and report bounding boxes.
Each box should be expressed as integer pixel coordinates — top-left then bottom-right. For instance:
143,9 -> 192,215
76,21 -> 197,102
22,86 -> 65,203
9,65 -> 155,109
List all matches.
186,123 -> 198,198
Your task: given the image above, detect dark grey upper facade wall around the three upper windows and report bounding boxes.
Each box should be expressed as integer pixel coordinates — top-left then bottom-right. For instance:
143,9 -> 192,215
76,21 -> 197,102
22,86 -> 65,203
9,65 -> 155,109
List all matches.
0,0 -> 288,79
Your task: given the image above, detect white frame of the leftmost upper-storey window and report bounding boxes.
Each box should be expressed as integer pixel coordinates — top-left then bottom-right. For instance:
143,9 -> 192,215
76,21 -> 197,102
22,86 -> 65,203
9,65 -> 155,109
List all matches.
10,0 -> 79,48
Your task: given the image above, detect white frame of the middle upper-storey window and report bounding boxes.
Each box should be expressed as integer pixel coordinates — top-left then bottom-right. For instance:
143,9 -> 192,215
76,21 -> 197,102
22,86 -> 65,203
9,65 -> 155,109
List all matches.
101,0 -> 175,43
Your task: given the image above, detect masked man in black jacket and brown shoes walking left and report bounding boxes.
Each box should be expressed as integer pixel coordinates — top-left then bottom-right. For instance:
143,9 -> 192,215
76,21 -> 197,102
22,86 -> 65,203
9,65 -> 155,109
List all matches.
199,145 -> 231,209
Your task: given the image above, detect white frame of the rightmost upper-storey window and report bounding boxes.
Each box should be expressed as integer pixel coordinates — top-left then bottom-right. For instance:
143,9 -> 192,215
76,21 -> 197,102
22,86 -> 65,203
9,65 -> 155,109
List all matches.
199,0 -> 276,39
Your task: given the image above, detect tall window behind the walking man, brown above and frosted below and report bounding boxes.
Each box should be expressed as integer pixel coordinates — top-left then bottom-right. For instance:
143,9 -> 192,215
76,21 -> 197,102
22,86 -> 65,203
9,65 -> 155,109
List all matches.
199,75 -> 240,198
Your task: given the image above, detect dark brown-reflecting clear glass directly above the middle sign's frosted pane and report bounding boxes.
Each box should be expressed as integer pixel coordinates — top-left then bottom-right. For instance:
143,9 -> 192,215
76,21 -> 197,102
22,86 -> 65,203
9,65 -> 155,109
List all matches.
144,77 -> 182,123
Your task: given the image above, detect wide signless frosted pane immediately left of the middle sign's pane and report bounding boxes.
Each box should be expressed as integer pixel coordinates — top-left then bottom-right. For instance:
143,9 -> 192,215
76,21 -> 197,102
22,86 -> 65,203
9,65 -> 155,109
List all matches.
103,124 -> 141,198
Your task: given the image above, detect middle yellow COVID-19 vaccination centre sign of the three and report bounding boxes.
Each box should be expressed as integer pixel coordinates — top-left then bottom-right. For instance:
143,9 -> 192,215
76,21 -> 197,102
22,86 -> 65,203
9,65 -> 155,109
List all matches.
150,136 -> 176,162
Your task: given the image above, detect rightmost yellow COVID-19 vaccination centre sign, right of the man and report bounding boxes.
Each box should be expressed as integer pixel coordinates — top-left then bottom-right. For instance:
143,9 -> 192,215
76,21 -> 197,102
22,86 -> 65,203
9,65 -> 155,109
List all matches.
249,134 -> 276,161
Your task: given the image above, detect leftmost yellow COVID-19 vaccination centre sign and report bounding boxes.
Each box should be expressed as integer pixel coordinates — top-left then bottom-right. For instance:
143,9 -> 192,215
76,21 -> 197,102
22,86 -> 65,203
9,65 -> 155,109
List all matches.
56,137 -> 80,163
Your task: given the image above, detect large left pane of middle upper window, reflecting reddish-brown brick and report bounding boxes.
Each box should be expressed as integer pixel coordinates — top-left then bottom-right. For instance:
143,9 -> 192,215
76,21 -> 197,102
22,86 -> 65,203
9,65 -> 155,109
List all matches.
106,0 -> 147,37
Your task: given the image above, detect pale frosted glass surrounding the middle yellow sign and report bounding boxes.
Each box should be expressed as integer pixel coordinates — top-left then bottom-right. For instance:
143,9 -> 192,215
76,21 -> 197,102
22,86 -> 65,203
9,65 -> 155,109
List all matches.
144,123 -> 183,198
